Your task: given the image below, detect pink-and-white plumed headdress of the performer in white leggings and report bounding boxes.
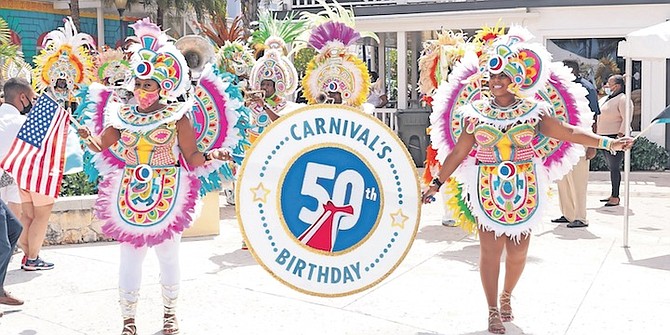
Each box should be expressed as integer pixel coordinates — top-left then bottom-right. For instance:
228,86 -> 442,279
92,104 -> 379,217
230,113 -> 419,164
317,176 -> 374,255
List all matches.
129,18 -> 191,99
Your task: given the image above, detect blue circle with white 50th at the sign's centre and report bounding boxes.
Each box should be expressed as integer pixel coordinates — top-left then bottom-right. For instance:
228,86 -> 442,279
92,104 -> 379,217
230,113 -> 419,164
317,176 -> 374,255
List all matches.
281,147 -> 382,252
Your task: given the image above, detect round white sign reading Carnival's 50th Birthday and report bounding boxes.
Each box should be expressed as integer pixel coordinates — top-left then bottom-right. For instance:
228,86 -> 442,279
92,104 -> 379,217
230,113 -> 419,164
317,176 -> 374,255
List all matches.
236,105 -> 421,296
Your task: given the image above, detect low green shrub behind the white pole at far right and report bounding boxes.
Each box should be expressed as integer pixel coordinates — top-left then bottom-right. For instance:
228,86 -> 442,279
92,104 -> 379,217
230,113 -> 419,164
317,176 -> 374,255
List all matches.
590,137 -> 670,171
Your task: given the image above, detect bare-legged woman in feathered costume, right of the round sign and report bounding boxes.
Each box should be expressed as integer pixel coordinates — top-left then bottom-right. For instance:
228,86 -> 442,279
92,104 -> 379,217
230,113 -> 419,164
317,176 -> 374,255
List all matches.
422,27 -> 633,334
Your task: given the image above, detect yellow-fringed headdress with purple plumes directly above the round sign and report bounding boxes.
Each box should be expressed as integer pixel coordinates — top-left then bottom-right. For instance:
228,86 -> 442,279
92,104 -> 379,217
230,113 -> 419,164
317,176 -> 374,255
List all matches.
302,0 -> 377,107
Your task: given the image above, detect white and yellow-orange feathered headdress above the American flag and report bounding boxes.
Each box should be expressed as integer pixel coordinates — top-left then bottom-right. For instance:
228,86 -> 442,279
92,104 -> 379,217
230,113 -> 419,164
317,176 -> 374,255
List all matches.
33,17 -> 95,100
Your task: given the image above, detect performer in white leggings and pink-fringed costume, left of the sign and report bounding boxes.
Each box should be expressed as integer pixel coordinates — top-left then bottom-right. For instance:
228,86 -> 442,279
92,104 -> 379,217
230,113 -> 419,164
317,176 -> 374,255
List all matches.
79,19 -> 234,335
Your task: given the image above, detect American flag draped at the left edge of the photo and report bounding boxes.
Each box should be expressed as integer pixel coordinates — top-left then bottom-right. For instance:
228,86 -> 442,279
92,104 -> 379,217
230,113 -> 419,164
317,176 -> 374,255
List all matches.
0,94 -> 68,198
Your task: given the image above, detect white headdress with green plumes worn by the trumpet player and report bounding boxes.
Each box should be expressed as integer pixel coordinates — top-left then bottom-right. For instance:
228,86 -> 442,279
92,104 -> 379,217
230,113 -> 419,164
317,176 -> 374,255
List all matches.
249,10 -> 306,95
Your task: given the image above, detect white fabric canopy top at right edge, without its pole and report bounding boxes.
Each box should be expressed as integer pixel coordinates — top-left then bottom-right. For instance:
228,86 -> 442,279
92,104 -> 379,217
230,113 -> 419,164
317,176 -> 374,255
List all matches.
618,21 -> 670,59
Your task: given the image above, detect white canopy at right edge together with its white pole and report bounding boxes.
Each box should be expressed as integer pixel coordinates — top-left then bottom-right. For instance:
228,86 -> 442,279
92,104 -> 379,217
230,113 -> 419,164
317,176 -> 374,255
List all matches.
618,21 -> 670,248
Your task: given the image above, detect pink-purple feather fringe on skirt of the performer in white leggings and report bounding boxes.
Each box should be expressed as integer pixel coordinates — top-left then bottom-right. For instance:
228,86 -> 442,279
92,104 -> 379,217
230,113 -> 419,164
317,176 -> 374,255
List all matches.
93,171 -> 200,248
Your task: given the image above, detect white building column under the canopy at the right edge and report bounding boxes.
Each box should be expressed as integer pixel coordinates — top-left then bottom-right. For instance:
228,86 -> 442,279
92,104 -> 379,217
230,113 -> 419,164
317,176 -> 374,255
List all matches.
641,60 -> 667,147
